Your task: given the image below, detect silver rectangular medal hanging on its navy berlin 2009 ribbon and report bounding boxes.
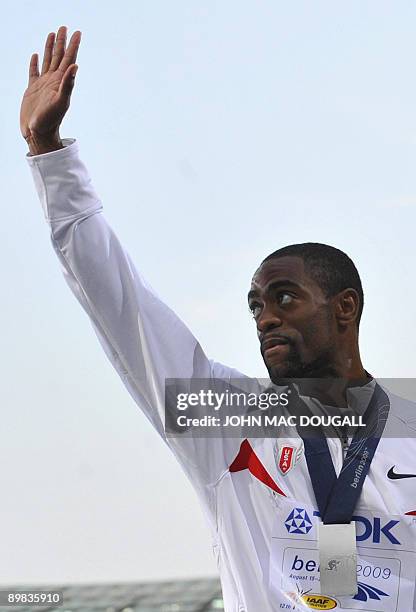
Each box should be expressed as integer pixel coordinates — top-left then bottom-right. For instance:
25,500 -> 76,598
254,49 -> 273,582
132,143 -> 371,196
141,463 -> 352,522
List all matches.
298,385 -> 390,596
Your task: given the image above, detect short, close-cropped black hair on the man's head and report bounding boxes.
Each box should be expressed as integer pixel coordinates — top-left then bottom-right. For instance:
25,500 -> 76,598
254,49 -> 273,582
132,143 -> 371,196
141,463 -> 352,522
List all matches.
262,242 -> 364,327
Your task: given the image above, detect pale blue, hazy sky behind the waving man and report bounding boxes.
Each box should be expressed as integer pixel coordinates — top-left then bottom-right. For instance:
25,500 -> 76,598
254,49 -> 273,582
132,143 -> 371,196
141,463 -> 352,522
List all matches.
0,0 -> 416,584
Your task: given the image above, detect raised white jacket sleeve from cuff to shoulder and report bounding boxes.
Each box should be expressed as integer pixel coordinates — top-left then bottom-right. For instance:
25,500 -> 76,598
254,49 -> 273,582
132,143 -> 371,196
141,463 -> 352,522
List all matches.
27,140 -> 254,492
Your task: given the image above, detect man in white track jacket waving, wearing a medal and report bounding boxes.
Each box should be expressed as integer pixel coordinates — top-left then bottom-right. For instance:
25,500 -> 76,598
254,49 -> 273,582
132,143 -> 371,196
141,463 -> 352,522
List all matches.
21,27 -> 416,612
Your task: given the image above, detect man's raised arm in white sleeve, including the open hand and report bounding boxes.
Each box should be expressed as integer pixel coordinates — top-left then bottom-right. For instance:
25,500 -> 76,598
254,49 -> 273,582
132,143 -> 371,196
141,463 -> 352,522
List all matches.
21,28 -> 254,488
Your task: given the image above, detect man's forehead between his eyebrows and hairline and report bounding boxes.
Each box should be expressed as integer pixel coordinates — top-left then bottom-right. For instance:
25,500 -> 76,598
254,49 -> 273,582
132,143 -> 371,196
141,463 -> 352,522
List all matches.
251,256 -> 318,292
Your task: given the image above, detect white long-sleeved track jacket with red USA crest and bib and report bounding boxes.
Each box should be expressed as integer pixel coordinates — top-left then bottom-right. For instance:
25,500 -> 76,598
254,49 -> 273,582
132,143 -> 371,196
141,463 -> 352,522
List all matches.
27,140 -> 416,612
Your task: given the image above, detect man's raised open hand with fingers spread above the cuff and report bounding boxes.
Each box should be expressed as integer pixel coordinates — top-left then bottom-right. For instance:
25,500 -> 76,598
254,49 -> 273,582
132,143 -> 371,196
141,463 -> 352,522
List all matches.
20,26 -> 81,140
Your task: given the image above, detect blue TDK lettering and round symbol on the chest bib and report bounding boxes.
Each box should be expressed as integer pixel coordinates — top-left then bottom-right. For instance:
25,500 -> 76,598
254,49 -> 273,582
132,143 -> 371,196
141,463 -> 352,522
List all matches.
285,508 -> 401,546
